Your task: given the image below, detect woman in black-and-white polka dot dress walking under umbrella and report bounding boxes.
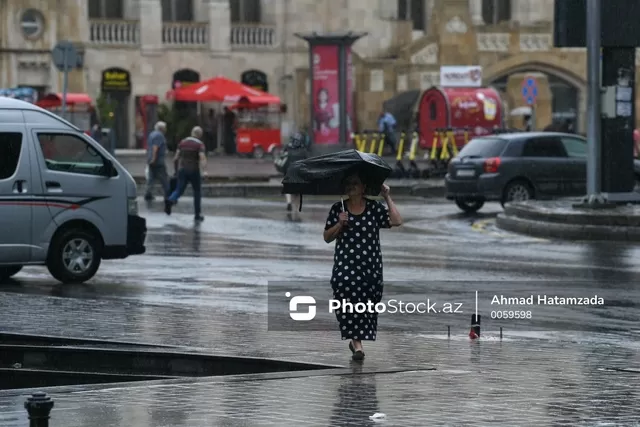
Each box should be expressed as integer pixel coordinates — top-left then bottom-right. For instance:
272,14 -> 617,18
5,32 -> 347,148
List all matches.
324,174 -> 402,360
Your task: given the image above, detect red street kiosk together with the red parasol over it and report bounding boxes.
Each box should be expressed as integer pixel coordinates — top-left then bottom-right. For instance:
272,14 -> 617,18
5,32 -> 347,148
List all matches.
167,76 -> 282,158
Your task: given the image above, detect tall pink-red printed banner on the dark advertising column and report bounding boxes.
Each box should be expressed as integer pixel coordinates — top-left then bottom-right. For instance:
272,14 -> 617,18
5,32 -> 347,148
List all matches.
310,46 -> 340,144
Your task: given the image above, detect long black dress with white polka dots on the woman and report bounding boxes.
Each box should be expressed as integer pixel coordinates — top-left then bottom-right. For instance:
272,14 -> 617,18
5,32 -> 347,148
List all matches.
325,199 -> 391,341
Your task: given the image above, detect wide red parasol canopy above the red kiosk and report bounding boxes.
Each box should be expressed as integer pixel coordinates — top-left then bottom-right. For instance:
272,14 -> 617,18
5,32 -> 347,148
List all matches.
167,76 -> 280,104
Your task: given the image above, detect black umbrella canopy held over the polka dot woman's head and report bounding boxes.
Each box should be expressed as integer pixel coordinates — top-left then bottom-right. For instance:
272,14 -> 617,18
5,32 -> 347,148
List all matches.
282,150 -> 392,196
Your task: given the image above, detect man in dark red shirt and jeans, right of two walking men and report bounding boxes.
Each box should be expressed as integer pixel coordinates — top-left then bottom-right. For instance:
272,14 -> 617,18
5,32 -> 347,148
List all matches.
165,126 -> 207,222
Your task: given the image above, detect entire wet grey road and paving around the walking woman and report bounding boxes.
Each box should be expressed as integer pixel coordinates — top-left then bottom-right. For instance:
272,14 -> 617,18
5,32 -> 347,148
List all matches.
0,198 -> 640,427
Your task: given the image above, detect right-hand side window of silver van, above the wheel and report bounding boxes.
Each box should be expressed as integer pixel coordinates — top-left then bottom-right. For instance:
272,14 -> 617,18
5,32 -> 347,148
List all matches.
38,132 -> 109,175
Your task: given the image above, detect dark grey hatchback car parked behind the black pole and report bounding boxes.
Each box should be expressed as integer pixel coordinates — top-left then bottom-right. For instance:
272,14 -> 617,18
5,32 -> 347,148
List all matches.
445,132 -> 640,212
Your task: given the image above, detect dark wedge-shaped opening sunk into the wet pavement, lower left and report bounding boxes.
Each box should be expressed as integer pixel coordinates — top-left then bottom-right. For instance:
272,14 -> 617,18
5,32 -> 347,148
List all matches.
0,334 -> 335,390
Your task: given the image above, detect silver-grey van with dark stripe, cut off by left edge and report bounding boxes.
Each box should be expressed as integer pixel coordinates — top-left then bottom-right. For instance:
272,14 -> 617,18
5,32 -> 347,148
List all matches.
0,97 -> 147,283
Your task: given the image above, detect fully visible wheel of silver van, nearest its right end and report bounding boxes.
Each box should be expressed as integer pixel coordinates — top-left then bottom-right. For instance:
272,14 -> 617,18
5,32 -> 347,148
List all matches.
47,228 -> 102,284
